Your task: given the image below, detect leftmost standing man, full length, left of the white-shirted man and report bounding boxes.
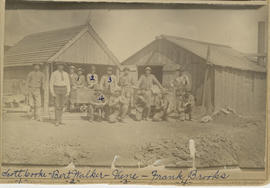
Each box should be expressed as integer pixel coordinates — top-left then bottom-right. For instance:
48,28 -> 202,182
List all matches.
26,64 -> 45,121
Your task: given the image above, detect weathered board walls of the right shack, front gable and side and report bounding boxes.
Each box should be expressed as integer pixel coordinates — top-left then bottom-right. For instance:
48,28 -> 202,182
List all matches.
124,39 -> 266,114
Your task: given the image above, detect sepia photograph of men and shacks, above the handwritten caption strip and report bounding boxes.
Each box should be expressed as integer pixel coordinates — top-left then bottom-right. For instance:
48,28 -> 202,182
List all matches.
1,0 -> 268,184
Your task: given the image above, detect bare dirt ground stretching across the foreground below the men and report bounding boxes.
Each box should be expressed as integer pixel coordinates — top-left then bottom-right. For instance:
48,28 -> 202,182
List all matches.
3,113 -> 265,168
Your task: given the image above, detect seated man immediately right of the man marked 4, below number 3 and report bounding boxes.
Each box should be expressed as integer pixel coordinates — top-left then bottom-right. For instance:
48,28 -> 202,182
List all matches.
108,88 -> 128,123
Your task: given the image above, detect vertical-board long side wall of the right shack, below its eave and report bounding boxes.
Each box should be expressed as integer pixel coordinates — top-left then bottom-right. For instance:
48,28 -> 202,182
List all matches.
214,66 -> 266,114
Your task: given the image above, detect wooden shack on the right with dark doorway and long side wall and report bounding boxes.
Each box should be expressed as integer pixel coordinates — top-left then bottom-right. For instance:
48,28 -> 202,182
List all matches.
122,35 -> 266,114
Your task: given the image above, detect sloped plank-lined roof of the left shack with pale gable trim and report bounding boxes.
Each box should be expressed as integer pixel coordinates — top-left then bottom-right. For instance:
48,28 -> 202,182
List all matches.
4,25 -> 119,66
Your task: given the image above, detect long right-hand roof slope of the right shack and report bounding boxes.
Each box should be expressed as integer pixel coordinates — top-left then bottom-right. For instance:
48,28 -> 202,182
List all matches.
161,35 -> 266,72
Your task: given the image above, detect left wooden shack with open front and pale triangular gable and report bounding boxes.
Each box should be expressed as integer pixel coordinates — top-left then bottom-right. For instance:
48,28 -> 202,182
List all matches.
4,24 -> 120,113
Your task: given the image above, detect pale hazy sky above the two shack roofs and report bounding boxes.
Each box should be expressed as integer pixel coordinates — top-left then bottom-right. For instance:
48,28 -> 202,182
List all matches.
5,7 -> 267,62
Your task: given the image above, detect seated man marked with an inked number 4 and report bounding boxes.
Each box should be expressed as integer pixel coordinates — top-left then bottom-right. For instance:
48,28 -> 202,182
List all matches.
87,88 -> 107,122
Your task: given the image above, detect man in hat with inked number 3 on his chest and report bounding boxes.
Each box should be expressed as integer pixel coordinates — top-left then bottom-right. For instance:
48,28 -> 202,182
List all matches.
100,67 -> 117,96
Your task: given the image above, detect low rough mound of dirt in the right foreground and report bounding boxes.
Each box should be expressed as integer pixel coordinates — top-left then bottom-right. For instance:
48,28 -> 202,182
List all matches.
134,134 -> 239,167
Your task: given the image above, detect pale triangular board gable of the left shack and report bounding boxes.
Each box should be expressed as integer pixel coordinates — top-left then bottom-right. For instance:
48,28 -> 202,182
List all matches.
55,32 -> 115,66
